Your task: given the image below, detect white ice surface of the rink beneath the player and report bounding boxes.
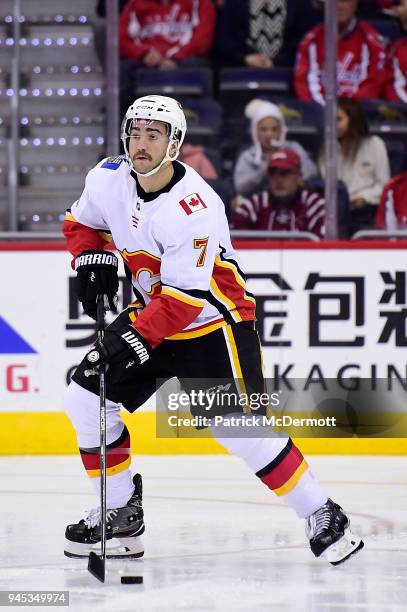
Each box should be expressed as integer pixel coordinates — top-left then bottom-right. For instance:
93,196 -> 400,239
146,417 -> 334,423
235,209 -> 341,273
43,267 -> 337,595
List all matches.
0,456 -> 407,612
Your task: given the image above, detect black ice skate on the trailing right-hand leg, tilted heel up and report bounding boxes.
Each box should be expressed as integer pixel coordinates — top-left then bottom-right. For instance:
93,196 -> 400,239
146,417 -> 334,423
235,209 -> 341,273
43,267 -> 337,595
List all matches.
305,499 -> 364,565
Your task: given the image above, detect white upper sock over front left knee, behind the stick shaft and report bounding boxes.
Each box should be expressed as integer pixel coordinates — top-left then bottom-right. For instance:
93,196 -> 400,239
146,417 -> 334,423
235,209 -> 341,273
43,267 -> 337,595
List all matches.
64,381 -> 123,448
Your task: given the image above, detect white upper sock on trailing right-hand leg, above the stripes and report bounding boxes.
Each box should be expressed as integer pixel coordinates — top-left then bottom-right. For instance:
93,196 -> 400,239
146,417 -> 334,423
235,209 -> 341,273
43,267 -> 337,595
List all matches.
211,414 -> 288,472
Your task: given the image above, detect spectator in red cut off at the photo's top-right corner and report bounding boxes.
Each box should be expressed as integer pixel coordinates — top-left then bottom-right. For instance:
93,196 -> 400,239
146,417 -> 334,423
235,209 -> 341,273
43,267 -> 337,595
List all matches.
385,0 -> 407,103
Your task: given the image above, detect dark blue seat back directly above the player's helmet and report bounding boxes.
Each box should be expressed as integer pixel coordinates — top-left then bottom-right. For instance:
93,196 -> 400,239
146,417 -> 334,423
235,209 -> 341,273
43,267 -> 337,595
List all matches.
135,68 -> 212,97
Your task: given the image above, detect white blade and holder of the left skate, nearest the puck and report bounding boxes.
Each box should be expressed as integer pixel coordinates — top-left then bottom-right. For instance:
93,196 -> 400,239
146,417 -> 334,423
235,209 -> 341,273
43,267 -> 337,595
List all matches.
64,537 -> 144,559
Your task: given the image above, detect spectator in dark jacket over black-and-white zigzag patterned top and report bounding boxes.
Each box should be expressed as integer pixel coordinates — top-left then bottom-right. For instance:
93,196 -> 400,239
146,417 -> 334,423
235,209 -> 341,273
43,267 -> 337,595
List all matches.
214,0 -> 287,68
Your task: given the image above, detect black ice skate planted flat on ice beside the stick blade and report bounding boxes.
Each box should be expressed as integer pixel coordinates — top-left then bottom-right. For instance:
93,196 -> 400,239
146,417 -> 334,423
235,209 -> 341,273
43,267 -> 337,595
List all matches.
64,474 -> 144,559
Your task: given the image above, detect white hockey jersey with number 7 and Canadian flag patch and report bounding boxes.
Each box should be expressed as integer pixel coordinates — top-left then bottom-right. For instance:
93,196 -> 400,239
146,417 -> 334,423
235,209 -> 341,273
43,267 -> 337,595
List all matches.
63,156 -> 255,347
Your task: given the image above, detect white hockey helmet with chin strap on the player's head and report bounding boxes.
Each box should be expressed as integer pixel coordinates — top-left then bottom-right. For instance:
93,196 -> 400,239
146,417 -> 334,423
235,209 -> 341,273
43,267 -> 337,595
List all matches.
121,95 -> 187,176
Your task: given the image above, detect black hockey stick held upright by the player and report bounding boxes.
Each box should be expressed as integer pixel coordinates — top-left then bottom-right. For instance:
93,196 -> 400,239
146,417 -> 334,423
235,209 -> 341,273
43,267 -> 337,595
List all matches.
88,295 -> 106,582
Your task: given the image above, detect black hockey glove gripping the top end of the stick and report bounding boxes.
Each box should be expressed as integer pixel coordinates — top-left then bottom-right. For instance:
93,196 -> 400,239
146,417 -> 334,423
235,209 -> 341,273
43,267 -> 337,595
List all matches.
75,250 -> 119,321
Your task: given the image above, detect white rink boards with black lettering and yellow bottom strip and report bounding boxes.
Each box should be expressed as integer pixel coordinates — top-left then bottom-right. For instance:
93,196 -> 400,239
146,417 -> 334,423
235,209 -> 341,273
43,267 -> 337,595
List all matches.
0,242 -> 407,454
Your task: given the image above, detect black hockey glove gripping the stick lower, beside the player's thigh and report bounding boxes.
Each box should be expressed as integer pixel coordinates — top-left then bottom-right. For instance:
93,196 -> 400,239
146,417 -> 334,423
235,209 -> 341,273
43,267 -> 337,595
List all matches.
86,325 -> 152,370
